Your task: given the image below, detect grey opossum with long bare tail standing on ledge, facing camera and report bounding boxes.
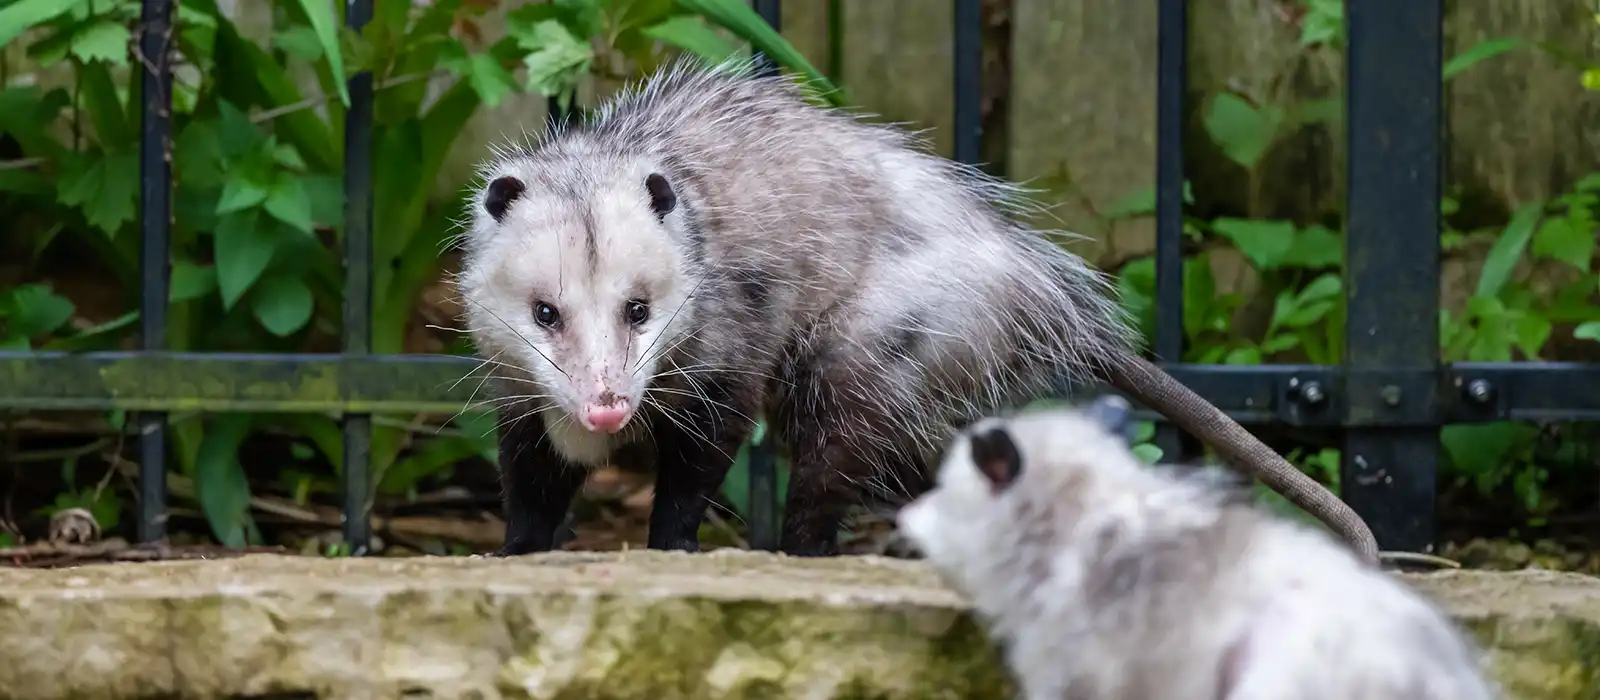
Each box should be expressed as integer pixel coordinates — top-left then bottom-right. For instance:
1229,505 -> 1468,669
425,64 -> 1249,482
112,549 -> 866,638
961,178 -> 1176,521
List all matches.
458,58 -> 1376,559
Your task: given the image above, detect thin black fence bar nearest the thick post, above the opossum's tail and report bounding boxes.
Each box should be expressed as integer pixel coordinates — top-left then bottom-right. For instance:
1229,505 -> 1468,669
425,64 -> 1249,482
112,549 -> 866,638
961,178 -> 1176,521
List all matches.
1154,0 -> 1189,460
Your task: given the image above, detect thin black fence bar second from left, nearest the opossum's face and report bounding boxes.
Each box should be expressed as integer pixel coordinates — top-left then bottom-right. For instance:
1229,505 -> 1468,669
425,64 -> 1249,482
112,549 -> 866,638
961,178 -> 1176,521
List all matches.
342,0 -> 373,556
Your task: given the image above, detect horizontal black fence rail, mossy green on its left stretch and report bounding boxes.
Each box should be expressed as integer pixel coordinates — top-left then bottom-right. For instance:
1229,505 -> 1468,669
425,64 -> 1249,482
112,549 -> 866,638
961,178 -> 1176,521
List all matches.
0,352 -> 1600,427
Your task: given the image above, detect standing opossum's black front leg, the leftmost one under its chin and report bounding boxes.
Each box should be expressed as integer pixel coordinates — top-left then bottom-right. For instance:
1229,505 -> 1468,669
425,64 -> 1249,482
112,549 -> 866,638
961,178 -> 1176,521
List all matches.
493,406 -> 589,556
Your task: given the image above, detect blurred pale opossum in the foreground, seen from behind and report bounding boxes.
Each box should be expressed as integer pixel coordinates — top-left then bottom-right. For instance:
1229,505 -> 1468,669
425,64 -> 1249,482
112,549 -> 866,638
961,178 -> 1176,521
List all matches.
898,396 -> 1502,700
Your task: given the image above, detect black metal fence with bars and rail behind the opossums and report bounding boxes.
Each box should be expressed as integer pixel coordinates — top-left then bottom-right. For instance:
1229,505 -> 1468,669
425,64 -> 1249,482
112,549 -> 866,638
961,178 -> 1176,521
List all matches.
0,0 -> 1600,553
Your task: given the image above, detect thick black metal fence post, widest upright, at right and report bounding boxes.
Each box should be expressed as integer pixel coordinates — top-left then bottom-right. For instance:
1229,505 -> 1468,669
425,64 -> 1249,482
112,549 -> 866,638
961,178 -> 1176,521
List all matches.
1341,0 -> 1443,551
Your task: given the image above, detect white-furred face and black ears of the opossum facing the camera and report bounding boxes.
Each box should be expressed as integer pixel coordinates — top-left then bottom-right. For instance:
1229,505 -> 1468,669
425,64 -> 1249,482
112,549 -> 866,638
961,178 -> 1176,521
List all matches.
461,158 -> 691,444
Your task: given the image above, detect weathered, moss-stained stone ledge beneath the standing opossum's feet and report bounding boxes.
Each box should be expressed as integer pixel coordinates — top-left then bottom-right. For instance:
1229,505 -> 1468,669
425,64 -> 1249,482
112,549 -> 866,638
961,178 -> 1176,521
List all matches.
0,551 -> 1600,700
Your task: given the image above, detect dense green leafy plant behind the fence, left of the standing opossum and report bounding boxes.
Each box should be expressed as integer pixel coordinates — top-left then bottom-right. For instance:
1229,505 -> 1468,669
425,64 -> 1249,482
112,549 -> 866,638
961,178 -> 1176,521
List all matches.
0,0 -> 840,545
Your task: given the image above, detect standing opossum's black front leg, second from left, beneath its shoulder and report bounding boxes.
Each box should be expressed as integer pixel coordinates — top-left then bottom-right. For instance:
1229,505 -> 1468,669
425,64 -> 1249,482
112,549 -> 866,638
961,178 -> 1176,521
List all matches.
646,376 -> 757,551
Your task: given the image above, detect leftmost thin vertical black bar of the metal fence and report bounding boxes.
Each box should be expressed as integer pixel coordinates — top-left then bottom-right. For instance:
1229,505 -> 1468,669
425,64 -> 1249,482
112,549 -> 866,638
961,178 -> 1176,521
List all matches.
138,0 -> 173,542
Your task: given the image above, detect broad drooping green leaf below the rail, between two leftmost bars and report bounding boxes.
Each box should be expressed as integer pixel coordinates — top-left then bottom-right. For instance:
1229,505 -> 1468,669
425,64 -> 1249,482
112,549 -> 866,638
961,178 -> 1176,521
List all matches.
195,414 -> 253,547
